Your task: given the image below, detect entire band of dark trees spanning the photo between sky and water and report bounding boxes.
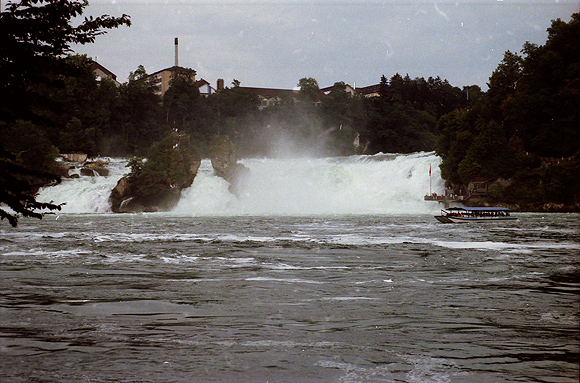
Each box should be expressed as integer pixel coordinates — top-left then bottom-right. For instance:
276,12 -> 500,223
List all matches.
0,0 -> 580,226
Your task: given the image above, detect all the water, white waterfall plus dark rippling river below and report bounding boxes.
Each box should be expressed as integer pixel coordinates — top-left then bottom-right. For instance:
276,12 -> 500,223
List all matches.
0,154 -> 580,383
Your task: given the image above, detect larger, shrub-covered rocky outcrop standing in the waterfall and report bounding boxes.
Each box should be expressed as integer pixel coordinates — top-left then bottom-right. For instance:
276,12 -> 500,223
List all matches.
109,132 -> 201,213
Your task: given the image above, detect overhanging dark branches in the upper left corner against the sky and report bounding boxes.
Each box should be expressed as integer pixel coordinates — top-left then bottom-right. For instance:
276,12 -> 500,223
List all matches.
0,0 -> 130,121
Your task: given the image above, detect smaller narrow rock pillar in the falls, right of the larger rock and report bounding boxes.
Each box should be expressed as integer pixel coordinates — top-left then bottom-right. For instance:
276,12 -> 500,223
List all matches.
209,135 -> 250,195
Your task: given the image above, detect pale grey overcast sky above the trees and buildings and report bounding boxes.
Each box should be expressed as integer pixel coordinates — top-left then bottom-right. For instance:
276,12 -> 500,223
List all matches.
69,0 -> 580,90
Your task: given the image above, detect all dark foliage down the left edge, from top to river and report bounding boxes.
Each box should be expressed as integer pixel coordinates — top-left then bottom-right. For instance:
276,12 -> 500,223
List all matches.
0,0 -> 130,226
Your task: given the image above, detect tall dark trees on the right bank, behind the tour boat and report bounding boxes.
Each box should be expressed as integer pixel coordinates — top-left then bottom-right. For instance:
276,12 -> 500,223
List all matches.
437,13 -> 580,208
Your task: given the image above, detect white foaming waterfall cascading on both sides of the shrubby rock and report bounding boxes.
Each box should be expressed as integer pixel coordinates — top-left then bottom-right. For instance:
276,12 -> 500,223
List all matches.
39,153 -> 443,216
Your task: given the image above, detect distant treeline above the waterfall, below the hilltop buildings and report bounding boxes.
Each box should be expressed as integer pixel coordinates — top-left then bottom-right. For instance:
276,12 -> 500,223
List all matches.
1,55 -> 472,160
